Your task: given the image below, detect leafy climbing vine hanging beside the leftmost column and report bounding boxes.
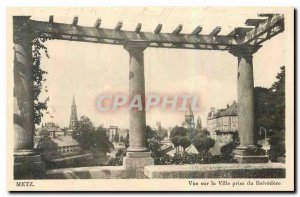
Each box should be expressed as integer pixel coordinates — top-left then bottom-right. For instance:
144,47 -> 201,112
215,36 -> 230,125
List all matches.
31,37 -> 49,125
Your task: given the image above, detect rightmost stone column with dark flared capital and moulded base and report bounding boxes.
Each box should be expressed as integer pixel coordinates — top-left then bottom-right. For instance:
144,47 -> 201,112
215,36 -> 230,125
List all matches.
231,46 -> 268,163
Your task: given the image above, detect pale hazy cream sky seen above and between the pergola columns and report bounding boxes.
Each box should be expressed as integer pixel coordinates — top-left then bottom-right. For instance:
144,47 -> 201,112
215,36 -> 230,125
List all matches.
32,8 -> 287,128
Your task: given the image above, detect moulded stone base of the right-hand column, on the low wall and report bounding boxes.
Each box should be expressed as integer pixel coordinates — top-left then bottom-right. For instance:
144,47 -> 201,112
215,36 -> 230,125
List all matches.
233,146 -> 269,163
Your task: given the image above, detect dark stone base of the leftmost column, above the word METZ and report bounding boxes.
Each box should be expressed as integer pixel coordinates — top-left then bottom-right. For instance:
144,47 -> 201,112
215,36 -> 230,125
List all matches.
14,150 -> 46,179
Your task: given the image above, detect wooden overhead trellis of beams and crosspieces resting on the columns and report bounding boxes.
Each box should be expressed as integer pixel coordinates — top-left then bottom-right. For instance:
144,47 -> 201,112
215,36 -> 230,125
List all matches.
14,14 -> 284,50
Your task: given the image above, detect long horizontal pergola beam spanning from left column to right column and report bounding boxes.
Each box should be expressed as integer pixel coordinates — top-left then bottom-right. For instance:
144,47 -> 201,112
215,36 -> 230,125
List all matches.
30,20 -> 236,48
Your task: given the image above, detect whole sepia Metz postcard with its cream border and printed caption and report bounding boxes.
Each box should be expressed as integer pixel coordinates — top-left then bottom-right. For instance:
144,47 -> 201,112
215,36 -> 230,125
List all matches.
7,7 -> 295,191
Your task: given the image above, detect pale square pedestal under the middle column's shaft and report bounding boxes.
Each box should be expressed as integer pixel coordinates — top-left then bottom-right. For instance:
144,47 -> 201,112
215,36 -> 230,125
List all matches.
123,152 -> 154,179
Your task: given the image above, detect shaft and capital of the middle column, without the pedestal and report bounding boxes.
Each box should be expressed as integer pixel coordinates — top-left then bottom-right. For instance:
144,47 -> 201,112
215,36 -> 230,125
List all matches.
124,42 -> 148,152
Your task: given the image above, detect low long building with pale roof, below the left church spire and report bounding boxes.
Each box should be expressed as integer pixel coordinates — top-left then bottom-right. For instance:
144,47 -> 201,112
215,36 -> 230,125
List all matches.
52,135 -> 81,155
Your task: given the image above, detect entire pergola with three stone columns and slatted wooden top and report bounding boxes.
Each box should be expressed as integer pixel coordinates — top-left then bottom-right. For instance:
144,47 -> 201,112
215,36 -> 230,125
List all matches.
13,14 -> 284,176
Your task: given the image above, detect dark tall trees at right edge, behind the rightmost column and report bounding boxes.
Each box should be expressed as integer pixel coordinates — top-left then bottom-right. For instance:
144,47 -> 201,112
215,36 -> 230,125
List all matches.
254,66 -> 285,161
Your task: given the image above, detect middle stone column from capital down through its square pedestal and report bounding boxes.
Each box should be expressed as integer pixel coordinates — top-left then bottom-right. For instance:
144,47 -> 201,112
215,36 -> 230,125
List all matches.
123,42 -> 154,178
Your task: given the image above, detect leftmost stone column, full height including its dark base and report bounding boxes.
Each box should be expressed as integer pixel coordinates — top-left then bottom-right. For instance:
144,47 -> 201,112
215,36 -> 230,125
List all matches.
13,17 -> 45,179
